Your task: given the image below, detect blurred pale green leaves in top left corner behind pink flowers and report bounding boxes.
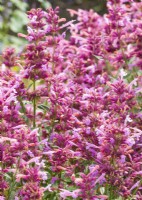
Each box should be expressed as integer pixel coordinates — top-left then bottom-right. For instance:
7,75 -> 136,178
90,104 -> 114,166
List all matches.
0,0 -> 51,52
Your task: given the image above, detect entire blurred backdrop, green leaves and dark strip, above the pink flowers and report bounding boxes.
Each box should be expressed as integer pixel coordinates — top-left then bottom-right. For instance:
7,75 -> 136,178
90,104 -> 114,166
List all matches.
0,0 -> 106,53
